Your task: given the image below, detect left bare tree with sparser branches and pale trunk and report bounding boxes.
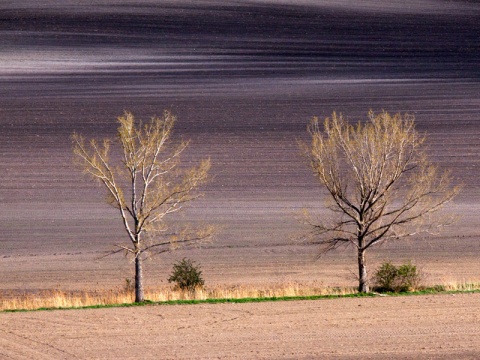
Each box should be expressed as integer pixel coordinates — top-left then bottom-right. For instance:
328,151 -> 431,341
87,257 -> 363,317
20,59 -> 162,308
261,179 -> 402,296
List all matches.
72,111 -> 212,302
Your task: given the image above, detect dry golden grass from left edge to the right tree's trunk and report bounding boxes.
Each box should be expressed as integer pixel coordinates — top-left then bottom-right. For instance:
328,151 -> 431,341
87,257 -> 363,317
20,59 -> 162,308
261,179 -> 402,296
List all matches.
0,282 -> 356,311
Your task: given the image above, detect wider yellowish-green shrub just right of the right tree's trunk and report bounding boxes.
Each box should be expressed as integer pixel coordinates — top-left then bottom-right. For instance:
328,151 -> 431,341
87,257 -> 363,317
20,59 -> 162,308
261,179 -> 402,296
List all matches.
374,261 -> 421,292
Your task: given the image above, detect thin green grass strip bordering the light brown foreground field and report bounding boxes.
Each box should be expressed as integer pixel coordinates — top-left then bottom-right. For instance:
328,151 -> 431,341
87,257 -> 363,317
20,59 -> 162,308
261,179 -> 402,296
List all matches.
1,287 -> 480,313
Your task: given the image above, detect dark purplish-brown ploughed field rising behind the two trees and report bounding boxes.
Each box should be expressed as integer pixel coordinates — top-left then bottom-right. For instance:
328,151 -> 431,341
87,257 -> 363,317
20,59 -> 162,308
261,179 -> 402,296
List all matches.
0,0 -> 480,291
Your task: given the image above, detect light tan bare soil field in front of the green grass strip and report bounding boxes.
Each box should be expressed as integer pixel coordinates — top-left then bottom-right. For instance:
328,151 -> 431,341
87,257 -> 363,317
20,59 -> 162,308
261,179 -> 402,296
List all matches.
0,294 -> 480,359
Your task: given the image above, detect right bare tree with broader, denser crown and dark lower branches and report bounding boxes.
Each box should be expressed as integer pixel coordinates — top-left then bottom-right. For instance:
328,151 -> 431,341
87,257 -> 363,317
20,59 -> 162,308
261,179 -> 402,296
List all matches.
302,112 -> 459,292
